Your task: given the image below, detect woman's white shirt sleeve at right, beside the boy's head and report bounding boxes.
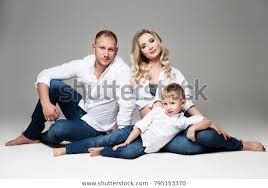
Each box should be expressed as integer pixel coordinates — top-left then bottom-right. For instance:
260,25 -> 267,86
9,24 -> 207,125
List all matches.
173,68 -> 194,112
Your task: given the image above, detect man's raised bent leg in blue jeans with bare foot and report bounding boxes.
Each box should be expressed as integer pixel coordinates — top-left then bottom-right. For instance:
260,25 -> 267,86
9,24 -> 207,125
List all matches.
6,80 -> 85,146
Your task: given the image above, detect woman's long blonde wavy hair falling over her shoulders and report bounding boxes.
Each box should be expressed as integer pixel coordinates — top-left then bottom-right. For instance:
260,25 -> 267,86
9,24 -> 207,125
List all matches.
130,29 -> 173,86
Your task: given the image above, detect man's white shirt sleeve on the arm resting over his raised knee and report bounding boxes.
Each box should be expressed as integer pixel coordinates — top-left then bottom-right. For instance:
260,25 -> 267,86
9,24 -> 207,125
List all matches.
35,59 -> 84,87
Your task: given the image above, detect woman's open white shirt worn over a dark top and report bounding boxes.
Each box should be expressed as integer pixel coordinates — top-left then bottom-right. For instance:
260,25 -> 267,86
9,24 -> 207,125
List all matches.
134,67 -> 194,112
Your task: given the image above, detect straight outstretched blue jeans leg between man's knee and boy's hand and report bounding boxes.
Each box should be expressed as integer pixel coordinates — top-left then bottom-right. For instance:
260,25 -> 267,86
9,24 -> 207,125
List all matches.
63,125 -> 133,154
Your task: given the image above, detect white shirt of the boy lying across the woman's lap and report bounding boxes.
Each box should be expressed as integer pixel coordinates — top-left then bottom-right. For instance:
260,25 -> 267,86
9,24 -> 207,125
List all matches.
134,107 -> 204,153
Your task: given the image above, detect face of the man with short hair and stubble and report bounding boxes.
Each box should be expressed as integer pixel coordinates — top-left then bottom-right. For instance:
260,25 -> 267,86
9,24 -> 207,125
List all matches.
92,35 -> 117,67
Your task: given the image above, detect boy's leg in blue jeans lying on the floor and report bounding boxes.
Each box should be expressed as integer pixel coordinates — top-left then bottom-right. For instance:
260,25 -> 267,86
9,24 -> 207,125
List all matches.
100,137 -> 145,159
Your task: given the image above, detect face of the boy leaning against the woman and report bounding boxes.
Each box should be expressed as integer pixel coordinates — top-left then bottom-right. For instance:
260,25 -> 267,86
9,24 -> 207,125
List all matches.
164,97 -> 185,117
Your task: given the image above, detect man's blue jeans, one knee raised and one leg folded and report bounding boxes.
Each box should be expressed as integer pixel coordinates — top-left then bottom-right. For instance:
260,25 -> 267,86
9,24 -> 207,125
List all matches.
23,80 -> 105,145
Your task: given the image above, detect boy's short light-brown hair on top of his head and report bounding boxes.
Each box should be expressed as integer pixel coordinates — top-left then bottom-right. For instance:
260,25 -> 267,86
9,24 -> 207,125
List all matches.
162,83 -> 185,100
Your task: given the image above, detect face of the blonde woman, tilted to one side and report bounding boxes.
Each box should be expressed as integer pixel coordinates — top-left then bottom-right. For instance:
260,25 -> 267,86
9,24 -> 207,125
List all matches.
139,33 -> 161,60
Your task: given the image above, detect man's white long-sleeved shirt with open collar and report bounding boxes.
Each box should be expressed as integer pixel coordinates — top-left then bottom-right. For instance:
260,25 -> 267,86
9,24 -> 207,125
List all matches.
35,55 -> 135,131
